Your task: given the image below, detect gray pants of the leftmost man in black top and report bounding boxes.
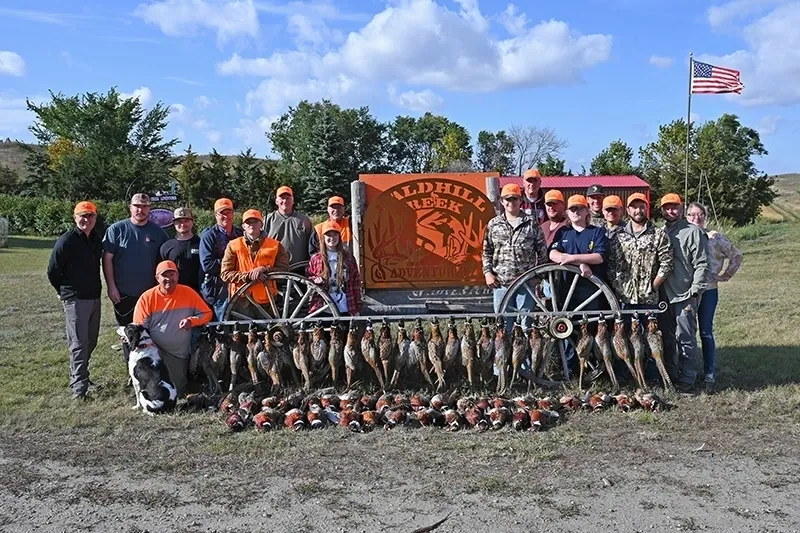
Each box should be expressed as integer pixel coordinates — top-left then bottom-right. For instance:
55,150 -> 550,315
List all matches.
63,298 -> 100,394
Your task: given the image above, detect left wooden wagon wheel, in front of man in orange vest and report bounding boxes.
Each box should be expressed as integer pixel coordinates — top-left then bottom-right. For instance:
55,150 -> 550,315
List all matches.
225,272 -> 339,324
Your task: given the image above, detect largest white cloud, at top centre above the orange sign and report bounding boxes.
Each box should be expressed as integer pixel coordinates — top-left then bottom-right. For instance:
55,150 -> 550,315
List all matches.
217,0 -> 612,115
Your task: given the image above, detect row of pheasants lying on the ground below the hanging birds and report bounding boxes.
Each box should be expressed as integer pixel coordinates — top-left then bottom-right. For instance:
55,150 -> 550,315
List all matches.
198,388 -> 666,432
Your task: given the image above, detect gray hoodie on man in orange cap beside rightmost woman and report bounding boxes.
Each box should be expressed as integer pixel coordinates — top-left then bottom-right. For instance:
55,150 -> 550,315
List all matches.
664,218 -> 708,304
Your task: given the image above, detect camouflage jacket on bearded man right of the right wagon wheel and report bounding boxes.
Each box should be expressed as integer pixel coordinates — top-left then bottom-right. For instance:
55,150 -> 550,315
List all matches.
608,221 -> 673,305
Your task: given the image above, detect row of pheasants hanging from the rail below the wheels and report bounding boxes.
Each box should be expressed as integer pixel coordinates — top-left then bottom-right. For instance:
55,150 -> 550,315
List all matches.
190,314 -> 672,393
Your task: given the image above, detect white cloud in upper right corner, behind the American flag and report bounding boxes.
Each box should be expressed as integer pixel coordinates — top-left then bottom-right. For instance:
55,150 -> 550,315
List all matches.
697,2 -> 800,105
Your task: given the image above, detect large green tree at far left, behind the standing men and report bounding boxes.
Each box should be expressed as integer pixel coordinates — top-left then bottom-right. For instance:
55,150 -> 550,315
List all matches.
23,88 -> 178,200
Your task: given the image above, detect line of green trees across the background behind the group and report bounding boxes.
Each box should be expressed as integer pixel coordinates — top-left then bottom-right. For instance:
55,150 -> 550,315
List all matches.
0,88 -> 775,224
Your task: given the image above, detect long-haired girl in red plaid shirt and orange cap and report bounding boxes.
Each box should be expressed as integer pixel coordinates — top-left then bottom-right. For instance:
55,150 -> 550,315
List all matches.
306,221 -> 362,316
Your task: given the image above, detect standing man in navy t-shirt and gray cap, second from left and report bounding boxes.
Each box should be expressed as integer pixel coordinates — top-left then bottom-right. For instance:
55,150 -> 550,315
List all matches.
103,193 -> 169,330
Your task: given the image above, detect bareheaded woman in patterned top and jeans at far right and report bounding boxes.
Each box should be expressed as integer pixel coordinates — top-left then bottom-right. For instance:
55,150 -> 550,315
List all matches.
686,202 -> 742,394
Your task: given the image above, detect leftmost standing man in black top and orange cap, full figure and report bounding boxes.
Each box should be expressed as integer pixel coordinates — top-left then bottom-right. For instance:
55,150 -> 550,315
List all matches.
47,202 -> 103,400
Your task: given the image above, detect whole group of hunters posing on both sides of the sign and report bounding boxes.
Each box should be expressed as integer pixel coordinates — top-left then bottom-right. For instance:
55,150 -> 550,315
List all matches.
47,169 -> 742,400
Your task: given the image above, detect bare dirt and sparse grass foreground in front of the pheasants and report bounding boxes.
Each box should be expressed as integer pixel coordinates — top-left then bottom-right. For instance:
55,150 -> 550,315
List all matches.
0,397 -> 800,533
